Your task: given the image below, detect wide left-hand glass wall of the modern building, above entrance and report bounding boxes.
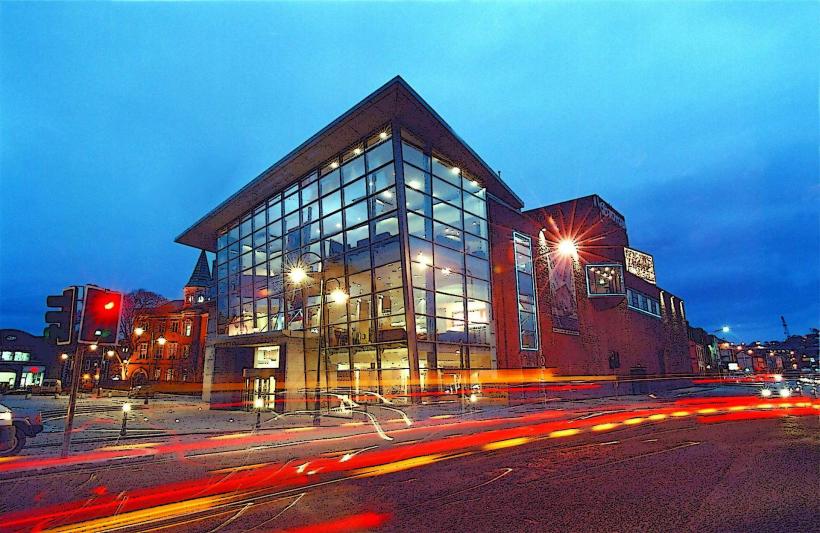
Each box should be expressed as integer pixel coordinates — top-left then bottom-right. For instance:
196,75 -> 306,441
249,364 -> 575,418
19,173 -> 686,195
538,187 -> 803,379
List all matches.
217,129 -> 410,394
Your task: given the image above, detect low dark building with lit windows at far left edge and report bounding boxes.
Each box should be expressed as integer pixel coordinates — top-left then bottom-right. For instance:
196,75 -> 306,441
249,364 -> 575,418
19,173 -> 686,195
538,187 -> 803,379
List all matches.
0,329 -> 59,390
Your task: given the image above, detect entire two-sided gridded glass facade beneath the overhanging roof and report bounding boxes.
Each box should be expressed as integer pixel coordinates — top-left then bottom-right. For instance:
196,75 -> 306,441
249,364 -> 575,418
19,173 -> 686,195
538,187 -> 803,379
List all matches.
208,121 -> 494,404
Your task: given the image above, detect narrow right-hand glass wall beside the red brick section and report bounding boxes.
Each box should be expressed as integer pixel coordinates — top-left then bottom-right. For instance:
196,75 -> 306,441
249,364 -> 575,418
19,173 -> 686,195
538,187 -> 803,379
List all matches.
402,141 -> 494,390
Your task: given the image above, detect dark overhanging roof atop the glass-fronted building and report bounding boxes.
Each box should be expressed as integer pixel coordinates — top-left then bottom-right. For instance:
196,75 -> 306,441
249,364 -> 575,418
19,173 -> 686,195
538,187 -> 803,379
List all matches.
176,76 -> 524,251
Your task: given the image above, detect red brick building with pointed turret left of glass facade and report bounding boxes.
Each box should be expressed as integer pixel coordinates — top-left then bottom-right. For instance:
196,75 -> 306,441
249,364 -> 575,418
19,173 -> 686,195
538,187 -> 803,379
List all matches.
126,252 -> 214,390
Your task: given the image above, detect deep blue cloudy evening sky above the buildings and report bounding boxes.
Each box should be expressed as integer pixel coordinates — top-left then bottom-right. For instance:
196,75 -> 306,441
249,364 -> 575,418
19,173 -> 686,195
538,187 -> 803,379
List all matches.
0,1 -> 820,340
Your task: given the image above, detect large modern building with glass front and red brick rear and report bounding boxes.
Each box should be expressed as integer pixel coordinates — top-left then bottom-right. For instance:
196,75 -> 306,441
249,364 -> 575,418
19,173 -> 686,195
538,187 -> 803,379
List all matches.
177,78 -> 685,410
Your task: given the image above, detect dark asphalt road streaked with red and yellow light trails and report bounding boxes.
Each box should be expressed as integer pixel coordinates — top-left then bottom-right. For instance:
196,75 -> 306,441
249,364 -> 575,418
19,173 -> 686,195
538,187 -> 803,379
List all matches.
0,388 -> 820,532
